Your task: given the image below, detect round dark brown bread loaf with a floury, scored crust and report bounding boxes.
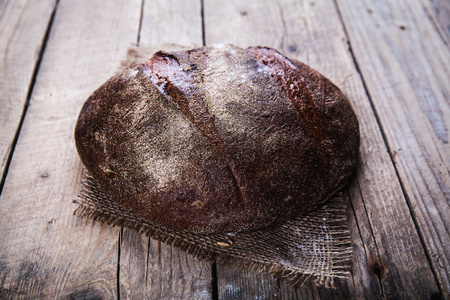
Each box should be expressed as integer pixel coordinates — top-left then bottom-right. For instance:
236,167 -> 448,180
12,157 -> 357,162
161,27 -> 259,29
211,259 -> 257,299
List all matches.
75,45 -> 359,233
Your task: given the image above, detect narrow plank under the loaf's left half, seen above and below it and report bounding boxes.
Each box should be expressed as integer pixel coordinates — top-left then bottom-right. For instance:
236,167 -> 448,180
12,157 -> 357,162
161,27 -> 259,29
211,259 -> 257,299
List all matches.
120,0 -> 213,299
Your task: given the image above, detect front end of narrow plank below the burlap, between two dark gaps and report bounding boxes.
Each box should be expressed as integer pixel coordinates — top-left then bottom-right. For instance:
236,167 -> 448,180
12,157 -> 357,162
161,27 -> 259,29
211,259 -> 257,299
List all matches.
120,228 -> 212,299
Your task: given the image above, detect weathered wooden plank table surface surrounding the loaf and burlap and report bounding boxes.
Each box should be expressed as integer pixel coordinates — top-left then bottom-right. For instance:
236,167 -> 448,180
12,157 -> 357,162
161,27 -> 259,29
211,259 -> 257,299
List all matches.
0,0 -> 450,299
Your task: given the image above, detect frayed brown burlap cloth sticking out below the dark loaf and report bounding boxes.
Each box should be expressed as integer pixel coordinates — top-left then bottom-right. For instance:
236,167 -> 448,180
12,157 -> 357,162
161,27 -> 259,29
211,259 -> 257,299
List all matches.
74,175 -> 352,287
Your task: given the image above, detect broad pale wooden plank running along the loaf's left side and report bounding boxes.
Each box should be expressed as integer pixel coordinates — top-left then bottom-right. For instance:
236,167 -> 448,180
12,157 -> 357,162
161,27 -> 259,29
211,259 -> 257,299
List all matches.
0,0 -> 141,299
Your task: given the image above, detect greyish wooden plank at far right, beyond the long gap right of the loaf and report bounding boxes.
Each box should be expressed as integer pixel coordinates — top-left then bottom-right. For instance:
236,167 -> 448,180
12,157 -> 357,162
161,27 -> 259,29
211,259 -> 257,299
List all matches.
338,0 -> 450,297
